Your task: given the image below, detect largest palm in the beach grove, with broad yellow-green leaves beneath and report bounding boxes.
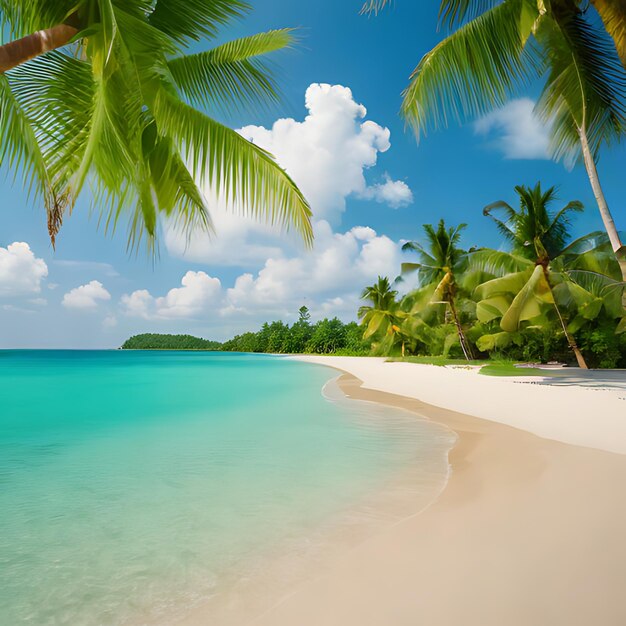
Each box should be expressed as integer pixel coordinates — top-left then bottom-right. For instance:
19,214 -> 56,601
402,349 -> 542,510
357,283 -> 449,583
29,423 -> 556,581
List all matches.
468,183 -> 623,368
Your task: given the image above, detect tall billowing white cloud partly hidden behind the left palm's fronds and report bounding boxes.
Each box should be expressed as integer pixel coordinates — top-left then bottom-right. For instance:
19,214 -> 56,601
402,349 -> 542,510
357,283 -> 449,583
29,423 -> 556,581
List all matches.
164,83 -> 413,266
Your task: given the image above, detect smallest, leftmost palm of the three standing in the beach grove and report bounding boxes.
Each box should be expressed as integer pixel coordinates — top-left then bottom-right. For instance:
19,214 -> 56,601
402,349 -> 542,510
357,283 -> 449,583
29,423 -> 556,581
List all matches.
358,276 -> 406,356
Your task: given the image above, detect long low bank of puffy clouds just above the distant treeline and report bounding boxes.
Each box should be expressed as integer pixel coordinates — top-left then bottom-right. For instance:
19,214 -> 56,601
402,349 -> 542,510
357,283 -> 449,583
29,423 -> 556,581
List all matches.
120,220 -> 401,329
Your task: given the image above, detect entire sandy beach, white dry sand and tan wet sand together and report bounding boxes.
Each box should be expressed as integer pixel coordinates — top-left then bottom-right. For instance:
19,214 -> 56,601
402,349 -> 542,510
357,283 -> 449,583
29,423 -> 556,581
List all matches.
244,357 -> 626,626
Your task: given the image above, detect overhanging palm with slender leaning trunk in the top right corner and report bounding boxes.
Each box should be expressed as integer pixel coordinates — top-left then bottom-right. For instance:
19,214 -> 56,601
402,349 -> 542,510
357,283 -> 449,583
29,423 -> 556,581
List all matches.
365,0 -> 626,280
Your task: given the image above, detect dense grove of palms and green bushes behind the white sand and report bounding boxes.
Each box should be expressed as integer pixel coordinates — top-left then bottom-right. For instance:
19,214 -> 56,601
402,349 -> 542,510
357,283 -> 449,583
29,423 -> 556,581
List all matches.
359,183 -> 626,368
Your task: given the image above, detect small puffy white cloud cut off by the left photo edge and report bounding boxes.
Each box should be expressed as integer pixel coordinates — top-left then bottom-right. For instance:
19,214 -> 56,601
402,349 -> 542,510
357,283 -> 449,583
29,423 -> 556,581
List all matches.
0,241 -> 48,296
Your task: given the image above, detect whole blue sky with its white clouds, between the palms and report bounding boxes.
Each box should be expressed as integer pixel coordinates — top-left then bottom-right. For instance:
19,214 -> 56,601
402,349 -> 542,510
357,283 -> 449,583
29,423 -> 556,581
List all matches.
0,0 -> 626,348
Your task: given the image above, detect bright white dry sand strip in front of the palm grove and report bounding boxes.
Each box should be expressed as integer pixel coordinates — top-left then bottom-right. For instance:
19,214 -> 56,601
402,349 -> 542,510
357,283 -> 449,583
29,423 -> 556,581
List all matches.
293,356 -> 626,454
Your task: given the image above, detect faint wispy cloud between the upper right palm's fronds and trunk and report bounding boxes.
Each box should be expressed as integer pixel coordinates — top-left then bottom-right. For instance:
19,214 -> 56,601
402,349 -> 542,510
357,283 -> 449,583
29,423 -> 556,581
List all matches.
474,98 -> 550,159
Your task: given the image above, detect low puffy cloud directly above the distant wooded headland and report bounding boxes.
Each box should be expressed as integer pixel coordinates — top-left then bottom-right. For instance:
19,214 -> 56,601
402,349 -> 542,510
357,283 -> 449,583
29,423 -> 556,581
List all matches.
121,271 -> 222,319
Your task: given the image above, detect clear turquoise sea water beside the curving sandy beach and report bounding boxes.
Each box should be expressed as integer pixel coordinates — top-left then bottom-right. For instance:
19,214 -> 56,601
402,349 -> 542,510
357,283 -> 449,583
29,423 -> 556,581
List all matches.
0,351 -> 450,626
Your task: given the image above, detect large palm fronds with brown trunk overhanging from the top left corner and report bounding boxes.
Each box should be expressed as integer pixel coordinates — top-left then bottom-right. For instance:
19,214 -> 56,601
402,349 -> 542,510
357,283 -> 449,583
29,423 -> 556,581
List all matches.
0,0 -> 312,247
